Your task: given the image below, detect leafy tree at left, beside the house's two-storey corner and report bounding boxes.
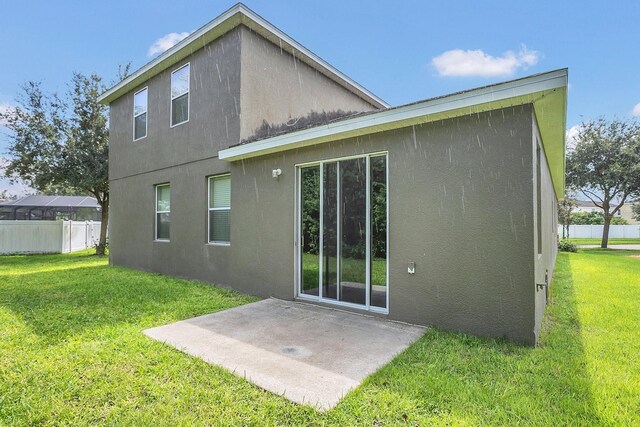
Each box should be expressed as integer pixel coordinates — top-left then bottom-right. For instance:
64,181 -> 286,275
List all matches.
0,73 -> 109,255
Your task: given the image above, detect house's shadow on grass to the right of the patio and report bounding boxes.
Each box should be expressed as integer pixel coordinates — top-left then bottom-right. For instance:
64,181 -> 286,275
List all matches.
336,255 -> 603,426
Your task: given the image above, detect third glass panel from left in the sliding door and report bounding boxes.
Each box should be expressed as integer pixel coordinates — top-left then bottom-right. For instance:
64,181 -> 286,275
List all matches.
338,157 -> 367,305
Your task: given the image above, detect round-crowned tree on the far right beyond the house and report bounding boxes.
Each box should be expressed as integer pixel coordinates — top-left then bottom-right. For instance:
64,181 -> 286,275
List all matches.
567,118 -> 640,248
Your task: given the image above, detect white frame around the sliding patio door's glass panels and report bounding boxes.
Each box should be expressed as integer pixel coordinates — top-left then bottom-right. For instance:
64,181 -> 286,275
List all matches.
293,151 -> 391,314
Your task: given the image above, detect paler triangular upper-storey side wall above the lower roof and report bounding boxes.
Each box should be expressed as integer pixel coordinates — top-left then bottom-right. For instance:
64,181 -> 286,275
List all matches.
240,26 -> 376,139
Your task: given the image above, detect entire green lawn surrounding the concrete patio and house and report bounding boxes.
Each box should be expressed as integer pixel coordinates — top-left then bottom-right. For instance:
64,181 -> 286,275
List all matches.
0,250 -> 640,426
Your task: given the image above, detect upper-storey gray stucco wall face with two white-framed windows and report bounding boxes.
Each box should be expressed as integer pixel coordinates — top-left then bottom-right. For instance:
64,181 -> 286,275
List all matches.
109,28 -> 241,181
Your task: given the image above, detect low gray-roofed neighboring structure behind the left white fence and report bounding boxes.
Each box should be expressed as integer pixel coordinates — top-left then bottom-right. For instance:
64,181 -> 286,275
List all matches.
0,196 -> 100,221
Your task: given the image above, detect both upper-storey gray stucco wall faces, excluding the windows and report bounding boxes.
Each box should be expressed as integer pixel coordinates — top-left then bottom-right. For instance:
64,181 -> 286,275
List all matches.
109,26 -> 374,181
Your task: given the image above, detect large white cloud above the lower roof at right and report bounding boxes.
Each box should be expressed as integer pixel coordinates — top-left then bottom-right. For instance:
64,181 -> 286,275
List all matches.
431,45 -> 540,77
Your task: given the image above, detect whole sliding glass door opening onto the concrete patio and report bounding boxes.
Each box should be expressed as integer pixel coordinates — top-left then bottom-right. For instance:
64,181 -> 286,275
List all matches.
298,154 -> 388,311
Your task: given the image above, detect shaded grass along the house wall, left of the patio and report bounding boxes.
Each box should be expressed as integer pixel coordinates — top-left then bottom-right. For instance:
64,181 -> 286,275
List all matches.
0,254 -> 253,343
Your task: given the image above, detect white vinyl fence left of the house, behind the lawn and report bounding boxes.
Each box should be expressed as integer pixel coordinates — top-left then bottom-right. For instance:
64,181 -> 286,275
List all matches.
0,221 -> 100,254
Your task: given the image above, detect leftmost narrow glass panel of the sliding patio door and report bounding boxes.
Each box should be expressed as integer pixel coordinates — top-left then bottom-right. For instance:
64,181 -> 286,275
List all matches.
299,166 -> 320,296
